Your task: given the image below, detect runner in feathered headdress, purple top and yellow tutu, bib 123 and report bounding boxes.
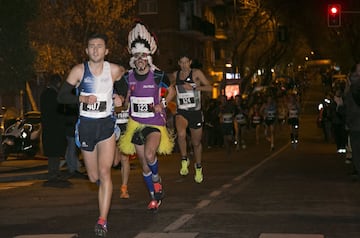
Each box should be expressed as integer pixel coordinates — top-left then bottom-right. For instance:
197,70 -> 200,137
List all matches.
117,22 -> 175,211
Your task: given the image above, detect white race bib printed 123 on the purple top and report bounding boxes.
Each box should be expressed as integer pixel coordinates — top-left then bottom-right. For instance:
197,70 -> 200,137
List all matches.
130,97 -> 155,118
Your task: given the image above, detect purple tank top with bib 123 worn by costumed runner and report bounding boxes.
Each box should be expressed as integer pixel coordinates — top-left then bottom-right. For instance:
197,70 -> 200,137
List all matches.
129,71 -> 166,126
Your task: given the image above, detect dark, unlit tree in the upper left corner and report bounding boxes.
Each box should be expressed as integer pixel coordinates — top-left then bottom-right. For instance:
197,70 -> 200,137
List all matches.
0,0 -> 36,93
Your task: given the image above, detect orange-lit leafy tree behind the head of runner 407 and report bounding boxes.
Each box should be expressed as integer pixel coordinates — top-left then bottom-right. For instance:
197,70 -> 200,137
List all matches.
30,0 -> 135,75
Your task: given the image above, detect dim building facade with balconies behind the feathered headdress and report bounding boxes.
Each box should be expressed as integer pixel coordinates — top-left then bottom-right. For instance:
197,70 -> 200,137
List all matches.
137,0 -> 232,98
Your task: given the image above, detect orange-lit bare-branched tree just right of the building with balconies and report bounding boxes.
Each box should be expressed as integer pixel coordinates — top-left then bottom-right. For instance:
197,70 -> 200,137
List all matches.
219,0 -> 289,87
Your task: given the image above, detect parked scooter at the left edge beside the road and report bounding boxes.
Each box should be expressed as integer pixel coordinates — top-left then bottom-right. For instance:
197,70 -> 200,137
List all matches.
1,112 -> 41,160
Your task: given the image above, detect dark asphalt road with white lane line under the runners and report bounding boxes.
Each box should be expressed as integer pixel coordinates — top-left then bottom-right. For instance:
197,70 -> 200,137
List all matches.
0,76 -> 360,238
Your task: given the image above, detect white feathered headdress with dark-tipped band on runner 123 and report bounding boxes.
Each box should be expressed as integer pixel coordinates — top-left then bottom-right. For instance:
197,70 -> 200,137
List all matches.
128,22 -> 157,55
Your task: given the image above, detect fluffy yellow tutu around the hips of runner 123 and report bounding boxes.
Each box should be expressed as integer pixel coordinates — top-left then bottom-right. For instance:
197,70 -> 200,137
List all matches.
118,118 -> 174,155
